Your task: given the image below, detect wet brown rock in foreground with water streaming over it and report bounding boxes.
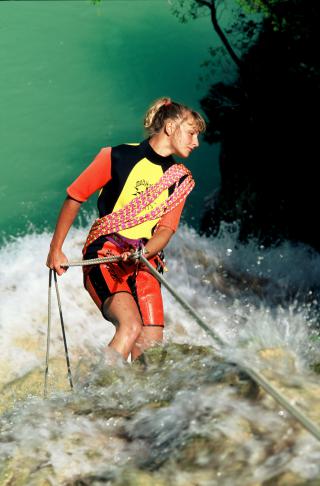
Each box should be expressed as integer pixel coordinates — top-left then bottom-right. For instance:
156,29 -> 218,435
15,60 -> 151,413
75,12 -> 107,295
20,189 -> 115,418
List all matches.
0,344 -> 320,486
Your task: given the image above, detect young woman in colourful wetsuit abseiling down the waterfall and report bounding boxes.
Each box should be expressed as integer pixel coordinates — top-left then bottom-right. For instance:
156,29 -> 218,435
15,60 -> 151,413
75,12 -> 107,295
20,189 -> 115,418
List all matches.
47,98 -> 205,360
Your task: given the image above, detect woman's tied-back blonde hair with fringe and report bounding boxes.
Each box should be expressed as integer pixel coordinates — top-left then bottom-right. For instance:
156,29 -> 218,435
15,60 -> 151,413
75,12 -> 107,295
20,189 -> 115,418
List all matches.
143,97 -> 206,136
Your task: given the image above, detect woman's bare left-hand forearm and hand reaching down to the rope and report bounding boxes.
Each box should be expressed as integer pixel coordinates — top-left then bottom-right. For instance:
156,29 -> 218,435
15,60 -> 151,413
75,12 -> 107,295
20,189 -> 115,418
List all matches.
47,197 -> 81,275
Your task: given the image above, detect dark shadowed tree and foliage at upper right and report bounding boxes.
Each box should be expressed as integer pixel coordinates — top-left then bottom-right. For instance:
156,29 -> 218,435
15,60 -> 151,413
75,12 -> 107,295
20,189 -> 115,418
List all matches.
176,0 -> 320,250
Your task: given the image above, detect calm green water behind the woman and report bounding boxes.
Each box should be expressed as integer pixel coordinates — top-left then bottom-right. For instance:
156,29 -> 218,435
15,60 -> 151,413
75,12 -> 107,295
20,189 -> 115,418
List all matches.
0,0 -> 219,241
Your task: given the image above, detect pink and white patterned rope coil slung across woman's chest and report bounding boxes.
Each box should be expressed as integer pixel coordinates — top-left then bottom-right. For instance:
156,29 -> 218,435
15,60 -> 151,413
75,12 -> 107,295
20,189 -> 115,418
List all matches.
83,164 -> 195,252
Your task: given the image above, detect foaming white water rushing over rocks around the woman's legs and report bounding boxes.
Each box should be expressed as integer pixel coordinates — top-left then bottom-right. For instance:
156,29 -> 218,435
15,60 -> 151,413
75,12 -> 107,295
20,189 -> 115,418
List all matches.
0,226 -> 320,486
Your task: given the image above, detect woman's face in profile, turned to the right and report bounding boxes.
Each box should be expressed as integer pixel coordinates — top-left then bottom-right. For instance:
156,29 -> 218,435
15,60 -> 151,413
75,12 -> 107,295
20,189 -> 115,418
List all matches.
170,115 -> 199,158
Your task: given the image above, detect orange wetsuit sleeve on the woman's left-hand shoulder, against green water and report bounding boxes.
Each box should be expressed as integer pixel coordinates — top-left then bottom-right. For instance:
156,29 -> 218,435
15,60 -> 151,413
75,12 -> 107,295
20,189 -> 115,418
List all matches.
67,147 -> 111,202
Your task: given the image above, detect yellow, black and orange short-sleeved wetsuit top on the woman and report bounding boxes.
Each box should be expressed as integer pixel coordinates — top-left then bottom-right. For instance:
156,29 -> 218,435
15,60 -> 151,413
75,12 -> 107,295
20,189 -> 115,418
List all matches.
67,140 -> 184,243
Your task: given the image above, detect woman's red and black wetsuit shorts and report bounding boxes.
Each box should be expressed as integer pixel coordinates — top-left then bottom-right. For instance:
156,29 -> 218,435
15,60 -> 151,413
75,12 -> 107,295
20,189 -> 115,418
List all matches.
83,241 -> 164,327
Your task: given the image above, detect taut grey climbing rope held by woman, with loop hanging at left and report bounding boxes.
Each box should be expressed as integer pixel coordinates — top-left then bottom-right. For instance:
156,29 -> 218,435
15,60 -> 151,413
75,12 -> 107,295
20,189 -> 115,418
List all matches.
45,252 -> 320,440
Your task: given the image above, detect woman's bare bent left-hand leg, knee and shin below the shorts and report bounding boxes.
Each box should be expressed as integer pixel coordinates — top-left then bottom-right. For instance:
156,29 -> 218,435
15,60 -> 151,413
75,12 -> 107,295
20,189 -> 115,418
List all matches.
103,292 -> 142,359
